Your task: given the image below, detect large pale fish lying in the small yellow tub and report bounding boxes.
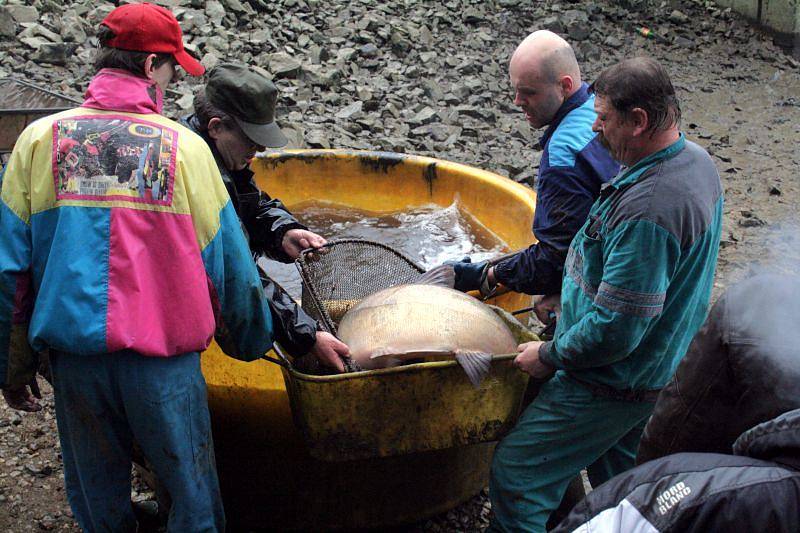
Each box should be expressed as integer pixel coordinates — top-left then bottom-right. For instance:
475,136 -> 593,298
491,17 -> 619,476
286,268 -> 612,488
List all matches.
338,270 -> 517,386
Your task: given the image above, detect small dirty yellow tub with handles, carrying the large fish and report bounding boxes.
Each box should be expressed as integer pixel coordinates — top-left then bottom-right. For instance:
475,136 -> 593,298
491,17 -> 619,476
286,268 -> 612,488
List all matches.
283,308 -> 538,461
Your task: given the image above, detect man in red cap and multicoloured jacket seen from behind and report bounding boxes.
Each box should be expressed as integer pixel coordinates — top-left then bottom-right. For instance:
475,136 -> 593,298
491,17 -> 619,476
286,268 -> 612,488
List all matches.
0,4 -> 273,532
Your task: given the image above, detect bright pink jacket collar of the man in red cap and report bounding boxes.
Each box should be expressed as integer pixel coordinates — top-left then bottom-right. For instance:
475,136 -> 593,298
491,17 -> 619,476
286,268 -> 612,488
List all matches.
81,68 -> 164,115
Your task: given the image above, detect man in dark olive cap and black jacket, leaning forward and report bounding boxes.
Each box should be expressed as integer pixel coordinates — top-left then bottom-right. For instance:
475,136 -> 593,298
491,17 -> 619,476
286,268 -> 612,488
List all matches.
181,63 -> 349,372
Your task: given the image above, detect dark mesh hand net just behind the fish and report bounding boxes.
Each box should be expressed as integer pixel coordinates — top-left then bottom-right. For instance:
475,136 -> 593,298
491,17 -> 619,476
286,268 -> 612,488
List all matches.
295,239 -> 425,335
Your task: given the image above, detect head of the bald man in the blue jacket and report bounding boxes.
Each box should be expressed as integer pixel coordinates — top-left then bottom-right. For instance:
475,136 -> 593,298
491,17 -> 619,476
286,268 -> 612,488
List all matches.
508,30 -> 581,128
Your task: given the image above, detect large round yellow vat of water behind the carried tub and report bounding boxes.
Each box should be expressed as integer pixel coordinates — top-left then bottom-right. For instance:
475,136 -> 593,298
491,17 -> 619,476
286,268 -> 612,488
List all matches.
202,150 -> 535,531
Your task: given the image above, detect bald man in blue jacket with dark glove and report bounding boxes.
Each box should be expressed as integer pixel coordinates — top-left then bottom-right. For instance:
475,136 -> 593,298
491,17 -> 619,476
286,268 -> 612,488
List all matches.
454,30 -> 619,306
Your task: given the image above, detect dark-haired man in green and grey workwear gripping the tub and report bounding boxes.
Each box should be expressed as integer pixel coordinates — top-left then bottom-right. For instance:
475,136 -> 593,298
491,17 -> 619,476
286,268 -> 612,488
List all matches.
490,58 -> 723,532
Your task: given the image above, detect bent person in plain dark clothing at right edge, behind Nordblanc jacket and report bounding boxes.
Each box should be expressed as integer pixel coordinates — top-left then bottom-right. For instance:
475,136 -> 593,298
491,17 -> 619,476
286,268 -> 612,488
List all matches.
637,274 -> 800,463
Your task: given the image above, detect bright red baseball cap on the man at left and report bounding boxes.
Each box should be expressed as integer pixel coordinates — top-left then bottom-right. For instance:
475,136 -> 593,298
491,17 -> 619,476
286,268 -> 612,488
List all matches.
101,3 -> 206,76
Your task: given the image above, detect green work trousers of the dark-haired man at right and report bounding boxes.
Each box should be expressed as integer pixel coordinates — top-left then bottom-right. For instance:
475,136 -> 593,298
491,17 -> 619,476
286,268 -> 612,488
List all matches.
489,372 -> 654,533
